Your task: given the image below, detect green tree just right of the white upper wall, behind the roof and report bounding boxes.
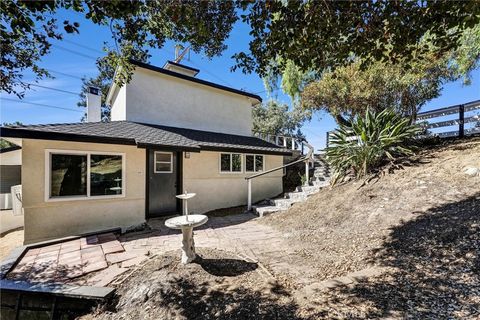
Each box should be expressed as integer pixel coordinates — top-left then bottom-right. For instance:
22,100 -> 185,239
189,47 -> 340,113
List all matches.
252,100 -> 306,135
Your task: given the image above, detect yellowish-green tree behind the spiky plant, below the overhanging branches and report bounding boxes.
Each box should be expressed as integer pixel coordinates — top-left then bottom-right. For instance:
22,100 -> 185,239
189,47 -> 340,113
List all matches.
302,24 -> 480,125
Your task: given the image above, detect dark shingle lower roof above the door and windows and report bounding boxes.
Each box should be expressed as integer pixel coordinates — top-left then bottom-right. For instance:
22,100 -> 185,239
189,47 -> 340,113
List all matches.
0,121 -> 290,154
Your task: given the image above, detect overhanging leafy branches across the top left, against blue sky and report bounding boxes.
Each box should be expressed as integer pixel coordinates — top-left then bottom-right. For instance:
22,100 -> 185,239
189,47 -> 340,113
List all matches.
0,0 -> 237,98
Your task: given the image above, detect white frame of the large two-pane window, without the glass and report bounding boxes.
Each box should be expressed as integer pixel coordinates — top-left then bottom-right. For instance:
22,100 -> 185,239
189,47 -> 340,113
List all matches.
44,149 -> 127,202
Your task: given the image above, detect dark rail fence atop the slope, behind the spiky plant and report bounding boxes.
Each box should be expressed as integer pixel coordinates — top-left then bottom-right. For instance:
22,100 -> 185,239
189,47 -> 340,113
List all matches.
326,100 -> 480,147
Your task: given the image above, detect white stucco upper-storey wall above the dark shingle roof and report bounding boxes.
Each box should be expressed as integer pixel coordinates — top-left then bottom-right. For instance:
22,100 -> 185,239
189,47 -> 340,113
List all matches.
112,67 -> 252,135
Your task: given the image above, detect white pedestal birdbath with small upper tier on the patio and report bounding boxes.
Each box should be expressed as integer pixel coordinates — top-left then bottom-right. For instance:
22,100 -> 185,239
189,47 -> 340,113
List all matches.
165,191 -> 208,264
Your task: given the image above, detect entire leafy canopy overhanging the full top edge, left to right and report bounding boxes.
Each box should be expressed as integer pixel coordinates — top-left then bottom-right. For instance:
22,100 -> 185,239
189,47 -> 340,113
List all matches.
0,0 -> 480,97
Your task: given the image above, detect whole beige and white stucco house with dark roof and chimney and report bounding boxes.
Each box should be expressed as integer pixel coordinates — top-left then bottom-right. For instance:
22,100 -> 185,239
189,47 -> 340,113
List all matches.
0,61 -> 291,243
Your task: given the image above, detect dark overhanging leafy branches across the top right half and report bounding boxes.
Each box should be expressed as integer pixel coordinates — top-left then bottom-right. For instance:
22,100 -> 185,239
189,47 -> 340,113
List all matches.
234,0 -> 480,75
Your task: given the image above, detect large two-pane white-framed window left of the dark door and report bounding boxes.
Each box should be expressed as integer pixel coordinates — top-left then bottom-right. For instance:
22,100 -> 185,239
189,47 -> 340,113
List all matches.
45,150 -> 125,201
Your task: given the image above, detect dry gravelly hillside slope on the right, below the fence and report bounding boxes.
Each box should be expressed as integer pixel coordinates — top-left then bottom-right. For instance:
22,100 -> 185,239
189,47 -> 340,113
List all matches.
263,138 -> 480,319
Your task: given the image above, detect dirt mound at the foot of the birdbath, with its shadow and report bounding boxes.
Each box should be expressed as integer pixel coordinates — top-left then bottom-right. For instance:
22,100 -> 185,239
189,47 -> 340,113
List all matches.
82,249 -> 296,320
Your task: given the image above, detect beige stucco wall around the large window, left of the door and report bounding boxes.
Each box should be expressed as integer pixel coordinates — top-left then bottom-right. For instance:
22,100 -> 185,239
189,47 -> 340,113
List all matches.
22,139 -> 145,243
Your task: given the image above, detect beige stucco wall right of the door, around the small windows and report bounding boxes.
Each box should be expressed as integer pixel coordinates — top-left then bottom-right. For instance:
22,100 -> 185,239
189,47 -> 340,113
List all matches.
183,152 -> 283,213
